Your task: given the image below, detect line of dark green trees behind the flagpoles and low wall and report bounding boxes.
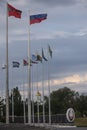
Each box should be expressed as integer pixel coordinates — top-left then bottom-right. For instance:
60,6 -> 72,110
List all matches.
0,87 -> 87,120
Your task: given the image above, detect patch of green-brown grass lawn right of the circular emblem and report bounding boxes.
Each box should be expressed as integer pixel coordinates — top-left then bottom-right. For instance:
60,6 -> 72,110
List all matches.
74,118 -> 87,127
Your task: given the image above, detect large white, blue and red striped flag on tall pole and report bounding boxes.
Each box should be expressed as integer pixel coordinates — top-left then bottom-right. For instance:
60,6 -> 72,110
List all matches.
30,14 -> 47,24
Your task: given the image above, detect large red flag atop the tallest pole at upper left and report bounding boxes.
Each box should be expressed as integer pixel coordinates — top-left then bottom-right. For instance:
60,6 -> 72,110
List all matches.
8,4 -> 22,18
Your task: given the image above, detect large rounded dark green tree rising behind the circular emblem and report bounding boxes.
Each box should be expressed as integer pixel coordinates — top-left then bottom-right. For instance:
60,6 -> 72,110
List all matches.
51,87 -> 77,114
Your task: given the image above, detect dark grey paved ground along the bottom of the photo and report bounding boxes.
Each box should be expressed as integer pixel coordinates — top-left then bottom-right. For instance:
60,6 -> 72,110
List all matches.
0,124 -> 87,130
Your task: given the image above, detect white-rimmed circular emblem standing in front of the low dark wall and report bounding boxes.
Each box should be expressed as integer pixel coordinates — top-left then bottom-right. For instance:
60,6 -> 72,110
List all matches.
66,108 -> 75,122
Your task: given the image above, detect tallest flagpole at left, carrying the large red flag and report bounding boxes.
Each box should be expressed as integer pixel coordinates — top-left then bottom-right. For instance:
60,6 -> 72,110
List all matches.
6,3 -> 9,124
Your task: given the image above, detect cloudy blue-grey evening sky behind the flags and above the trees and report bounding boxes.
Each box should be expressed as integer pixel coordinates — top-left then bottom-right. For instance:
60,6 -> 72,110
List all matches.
0,0 -> 87,98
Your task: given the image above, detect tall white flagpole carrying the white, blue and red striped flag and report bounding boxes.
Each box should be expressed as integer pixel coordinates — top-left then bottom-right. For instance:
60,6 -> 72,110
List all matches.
28,11 -> 31,124
